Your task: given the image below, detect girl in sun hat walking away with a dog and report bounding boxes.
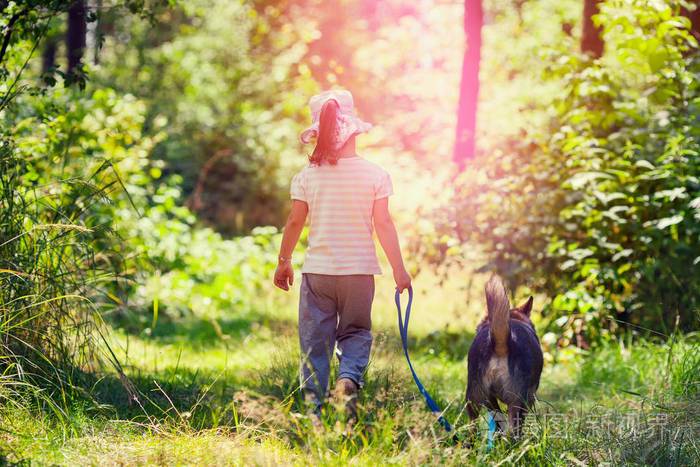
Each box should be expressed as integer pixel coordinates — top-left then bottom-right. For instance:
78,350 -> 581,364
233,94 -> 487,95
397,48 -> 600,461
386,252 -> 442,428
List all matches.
274,90 -> 411,426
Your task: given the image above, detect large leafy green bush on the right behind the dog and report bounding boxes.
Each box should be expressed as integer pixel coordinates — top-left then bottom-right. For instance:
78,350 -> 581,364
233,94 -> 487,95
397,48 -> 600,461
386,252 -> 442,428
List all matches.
432,1 -> 700,344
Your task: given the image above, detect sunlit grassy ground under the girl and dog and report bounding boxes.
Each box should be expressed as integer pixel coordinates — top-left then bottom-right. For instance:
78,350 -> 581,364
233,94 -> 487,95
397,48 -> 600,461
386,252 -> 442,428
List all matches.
0,270 -> 700,465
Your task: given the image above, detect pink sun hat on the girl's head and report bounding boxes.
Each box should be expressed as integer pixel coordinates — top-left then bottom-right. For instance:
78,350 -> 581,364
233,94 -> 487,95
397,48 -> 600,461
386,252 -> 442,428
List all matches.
299,89 -> 372,148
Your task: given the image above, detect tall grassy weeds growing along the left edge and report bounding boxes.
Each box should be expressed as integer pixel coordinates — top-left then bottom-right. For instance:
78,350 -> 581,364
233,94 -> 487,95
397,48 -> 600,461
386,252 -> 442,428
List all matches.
0,121 -> 138,428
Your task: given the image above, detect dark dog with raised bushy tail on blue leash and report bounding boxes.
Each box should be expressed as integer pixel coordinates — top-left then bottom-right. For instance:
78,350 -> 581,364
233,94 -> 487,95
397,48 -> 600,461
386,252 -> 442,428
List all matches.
466,275 -> 543,438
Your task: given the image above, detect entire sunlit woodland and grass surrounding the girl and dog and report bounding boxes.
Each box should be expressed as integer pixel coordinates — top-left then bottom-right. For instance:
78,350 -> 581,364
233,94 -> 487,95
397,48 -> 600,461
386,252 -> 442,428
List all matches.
0,0 -> 700,465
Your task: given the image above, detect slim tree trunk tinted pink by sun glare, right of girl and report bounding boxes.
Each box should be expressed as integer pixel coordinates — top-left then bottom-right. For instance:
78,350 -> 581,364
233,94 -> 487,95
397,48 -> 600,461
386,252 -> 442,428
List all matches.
452,0 -> 484,171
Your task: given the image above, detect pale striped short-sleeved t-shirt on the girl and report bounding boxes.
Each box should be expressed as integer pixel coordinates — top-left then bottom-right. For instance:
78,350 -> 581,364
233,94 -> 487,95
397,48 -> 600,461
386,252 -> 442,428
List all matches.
291,156 -> 393,276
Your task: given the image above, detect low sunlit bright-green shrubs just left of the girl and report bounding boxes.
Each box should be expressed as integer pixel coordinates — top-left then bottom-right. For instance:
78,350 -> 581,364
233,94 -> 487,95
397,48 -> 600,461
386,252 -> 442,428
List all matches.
116,203 -> 280,333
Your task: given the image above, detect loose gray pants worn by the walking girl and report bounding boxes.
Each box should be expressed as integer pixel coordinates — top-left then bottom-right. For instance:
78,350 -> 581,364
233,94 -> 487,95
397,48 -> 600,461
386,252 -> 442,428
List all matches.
299,273 -> 374,400
